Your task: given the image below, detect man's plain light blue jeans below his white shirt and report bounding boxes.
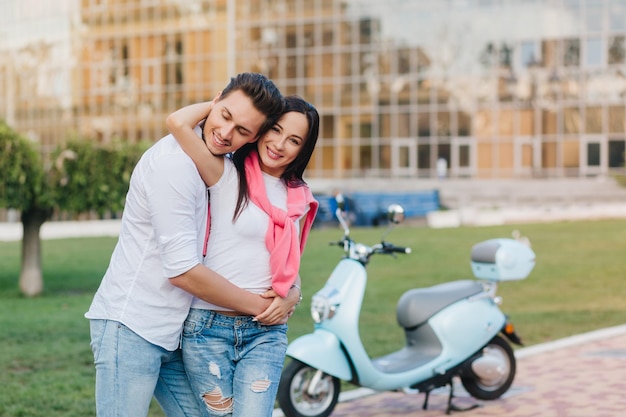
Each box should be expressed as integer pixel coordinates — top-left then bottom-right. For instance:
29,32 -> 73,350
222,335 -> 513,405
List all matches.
90,320 -> 202,417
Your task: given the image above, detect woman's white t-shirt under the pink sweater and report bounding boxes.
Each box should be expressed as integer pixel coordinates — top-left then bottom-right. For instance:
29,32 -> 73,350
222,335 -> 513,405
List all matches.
192,158 -> 290,311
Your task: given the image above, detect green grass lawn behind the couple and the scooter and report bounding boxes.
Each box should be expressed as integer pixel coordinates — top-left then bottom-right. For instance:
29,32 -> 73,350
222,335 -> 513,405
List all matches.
0,220 -> 626,417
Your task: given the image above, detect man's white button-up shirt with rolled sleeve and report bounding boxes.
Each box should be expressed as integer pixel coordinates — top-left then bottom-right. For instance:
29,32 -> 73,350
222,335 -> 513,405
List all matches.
85,129 -> 207,350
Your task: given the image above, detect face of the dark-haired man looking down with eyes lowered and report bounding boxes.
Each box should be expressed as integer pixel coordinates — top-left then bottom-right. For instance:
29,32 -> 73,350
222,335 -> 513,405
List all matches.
204,90 -> 265,155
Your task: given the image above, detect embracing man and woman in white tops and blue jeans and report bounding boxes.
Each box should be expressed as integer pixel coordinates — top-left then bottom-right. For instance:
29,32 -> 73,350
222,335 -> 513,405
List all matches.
85,73 -> 319,417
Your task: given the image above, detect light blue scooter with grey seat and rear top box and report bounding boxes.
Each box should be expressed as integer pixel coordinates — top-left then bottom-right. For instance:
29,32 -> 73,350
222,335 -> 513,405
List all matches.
277,196 -> 535,417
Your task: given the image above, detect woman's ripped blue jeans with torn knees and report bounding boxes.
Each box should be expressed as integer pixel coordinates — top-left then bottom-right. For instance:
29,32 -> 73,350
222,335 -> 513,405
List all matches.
182,308 -> 287,417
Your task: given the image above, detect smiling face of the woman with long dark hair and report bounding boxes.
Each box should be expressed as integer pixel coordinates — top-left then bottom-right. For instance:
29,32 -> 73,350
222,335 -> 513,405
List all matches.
258,111 -> 309,177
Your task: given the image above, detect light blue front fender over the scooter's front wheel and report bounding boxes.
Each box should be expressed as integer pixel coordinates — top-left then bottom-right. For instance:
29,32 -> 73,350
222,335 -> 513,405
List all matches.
287,329 -> 352,381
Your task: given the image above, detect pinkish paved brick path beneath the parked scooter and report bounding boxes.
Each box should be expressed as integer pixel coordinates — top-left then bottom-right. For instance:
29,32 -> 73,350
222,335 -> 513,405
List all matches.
275,326 -> 626,417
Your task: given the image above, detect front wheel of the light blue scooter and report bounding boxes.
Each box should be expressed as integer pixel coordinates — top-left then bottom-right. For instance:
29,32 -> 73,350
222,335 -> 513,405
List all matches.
277,360 -> 341,417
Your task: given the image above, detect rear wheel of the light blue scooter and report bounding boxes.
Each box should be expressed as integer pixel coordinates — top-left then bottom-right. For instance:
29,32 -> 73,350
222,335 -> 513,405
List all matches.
461,336 -> 516,400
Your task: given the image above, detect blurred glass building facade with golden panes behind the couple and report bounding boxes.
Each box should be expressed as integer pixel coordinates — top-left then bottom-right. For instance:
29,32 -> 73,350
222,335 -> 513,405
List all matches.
0,0 -> 626,179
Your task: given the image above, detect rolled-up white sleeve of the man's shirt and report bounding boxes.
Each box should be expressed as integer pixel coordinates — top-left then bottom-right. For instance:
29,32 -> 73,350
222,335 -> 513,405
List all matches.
144,152 -> 202,278
